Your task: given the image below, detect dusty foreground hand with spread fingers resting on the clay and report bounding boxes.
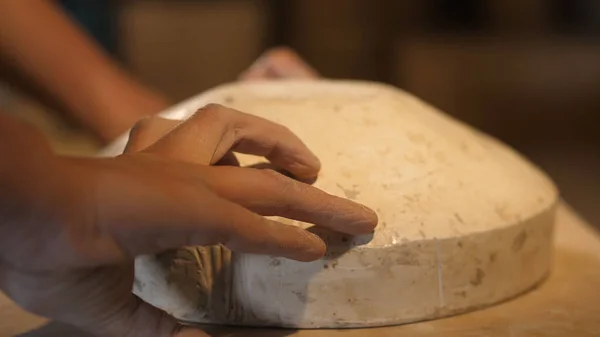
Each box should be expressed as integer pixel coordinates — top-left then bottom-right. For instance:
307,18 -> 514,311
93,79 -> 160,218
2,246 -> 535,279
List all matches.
0,105 -> 377,337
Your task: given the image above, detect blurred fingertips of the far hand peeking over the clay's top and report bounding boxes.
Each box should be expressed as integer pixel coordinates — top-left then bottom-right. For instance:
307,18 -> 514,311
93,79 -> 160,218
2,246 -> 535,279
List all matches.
239,47 -> 319,81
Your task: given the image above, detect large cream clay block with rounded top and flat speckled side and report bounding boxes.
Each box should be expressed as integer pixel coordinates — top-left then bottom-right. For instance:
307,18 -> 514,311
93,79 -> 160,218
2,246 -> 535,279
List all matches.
105,80 -> 558,328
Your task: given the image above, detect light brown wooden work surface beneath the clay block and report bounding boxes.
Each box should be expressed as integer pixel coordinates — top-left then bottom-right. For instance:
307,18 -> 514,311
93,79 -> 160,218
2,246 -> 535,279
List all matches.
0,204 -> 600,337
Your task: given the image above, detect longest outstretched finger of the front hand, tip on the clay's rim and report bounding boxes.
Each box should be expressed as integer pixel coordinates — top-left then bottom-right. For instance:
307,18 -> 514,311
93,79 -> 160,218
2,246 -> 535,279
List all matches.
198,167 -> 378,235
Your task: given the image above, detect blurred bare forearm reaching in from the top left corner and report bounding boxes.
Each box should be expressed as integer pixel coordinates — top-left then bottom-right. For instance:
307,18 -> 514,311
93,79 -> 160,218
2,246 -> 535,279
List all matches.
0,0 -> 167,141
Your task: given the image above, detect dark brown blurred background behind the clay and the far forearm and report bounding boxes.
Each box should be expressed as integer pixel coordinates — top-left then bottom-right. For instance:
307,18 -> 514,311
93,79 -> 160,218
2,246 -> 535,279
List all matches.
0,0 -> 600,228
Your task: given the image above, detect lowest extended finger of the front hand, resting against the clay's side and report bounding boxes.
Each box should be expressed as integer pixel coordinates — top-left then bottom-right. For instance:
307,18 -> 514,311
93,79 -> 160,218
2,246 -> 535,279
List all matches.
131,200 -> 326,261
